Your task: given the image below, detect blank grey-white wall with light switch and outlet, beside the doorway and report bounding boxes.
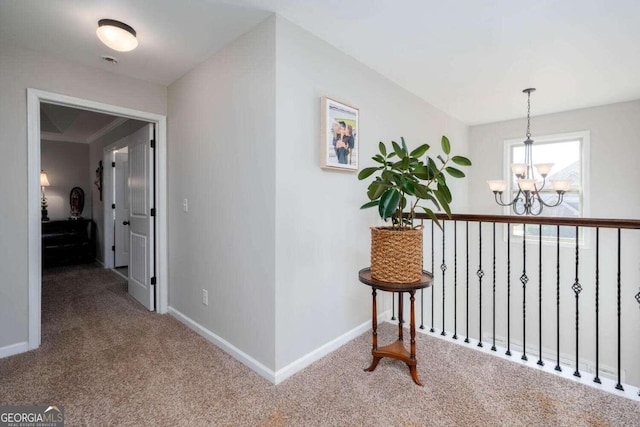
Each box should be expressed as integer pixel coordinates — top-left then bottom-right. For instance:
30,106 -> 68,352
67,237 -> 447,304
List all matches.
168,17 -> 275,369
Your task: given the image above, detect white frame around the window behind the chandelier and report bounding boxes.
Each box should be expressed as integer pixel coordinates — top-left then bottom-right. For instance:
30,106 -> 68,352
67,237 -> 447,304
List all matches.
502,130 -> 591,247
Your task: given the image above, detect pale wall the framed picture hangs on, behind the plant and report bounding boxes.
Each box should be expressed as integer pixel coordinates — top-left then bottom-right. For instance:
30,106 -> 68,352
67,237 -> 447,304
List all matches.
276,17 -> 467,369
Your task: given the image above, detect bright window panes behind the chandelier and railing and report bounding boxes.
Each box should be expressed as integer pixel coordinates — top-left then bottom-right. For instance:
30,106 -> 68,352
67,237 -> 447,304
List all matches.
505,132 -> 589,241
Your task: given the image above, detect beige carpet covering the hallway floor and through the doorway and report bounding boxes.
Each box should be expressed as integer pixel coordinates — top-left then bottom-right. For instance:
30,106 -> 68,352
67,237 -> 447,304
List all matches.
0,266 -> 640,426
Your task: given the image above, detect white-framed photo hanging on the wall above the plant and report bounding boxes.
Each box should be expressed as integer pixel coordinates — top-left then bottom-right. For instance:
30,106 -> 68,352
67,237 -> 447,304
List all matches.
320,96 -> 360,172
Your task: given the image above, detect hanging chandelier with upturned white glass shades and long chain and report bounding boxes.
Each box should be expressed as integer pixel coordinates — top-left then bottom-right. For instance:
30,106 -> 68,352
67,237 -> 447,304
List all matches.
487,88 -> 571,215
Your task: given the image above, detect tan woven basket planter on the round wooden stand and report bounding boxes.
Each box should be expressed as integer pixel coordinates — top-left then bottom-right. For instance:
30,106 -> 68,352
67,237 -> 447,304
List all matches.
371,227 -> 422,283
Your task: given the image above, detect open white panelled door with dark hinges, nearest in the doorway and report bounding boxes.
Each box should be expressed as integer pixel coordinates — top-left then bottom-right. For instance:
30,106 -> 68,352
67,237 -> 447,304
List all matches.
129,124 -> 155,310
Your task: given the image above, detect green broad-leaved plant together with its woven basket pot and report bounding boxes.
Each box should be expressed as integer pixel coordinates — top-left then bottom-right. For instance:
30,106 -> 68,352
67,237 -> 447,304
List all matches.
358,136 -> 471,283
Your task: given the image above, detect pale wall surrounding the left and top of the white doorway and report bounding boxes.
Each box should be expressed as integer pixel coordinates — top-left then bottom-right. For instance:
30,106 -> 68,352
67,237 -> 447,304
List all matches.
0,43 -> 166,349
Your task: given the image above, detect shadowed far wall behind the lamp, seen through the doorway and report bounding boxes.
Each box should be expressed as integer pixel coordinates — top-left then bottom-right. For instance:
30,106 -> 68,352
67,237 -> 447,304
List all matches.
40,141 -> 92,221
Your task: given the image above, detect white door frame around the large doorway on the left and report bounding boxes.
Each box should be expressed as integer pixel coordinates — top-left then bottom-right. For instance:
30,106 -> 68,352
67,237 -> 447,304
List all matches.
27,88 -> 169,350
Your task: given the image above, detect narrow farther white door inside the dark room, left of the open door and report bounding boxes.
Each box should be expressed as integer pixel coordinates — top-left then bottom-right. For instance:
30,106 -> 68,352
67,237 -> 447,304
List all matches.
113,148 -> 129,267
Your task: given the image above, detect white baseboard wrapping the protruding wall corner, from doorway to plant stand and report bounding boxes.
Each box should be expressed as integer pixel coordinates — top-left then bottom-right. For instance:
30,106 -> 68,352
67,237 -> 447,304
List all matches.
168,307 -> 391,384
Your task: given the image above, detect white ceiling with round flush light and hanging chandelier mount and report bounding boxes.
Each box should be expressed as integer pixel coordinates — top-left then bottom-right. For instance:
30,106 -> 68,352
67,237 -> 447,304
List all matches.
0,0 -> 640,124
